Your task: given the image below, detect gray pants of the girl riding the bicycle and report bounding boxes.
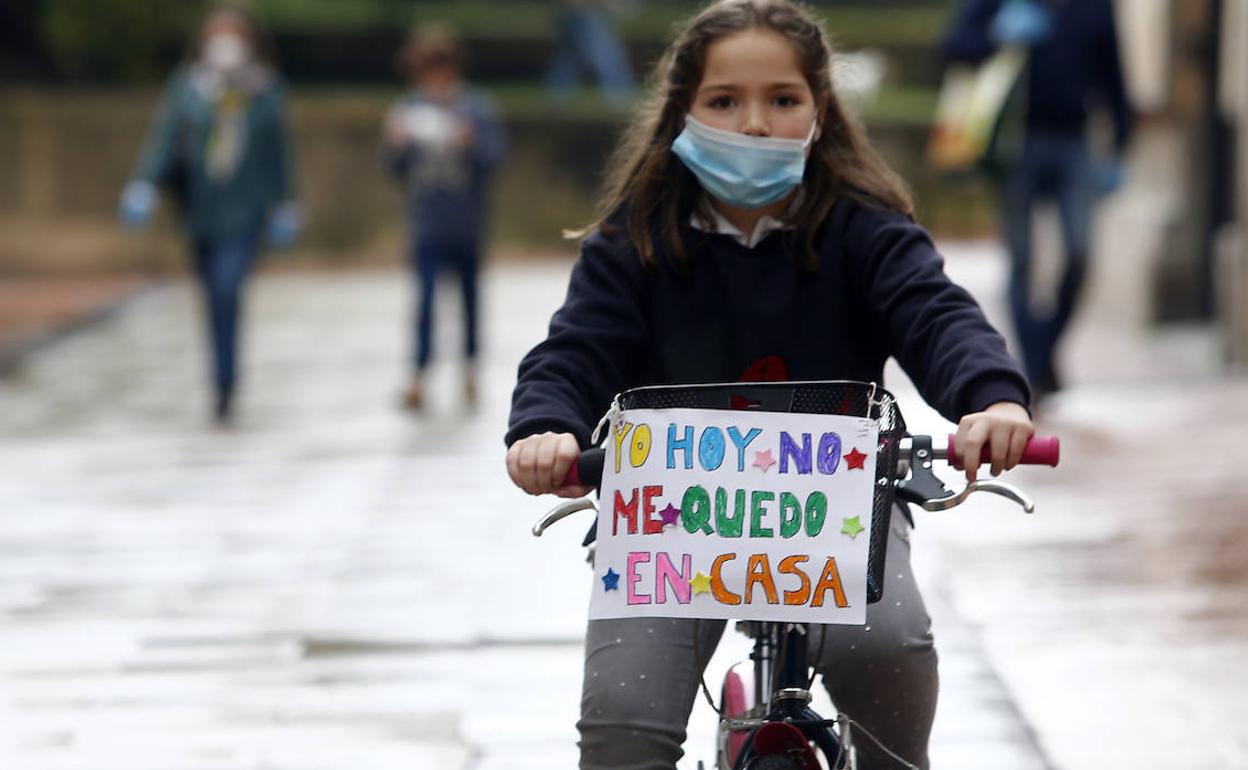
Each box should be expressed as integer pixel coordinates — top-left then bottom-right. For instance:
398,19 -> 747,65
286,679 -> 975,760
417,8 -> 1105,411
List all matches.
577,510 -> 937,770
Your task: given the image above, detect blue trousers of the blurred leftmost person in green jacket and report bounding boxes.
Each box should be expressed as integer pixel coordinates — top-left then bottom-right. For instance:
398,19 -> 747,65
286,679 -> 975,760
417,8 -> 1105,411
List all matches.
195,228 -> 260,397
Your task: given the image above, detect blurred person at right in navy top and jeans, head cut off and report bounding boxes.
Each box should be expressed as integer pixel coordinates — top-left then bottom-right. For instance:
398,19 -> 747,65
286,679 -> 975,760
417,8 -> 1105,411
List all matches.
945,0 -> 1131,402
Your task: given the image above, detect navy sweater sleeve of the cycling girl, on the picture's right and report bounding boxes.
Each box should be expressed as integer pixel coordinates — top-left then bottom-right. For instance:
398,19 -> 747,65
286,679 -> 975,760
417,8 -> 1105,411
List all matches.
846,207 -> 1031,422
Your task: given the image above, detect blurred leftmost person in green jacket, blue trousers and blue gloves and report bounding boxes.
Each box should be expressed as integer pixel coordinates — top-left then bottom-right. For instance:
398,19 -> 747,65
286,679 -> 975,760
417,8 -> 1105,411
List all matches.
120,5 -> 300,422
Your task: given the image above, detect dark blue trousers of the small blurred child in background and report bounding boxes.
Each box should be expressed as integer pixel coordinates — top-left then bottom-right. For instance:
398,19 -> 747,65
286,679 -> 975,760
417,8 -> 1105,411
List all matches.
412,240 -> 480,372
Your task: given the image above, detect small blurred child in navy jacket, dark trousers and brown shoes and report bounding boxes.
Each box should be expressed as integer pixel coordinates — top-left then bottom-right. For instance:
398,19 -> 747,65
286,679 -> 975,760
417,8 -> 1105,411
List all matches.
386,25 -> 505,409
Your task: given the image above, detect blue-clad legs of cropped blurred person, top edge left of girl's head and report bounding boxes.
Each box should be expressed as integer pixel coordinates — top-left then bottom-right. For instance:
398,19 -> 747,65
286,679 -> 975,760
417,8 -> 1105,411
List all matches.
547,0 -> 636,107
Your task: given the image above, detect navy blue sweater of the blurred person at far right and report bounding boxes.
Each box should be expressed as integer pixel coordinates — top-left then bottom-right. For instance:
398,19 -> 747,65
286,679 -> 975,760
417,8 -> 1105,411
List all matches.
945,0 -> 1131,150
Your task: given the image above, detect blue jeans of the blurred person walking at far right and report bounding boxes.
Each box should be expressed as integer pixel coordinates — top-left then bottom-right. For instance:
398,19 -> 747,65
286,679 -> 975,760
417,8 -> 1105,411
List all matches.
1005,130 -> 1096,389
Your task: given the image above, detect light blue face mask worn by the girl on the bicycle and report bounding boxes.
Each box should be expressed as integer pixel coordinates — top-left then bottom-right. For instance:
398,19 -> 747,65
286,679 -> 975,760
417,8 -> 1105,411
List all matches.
671,115 -> 816,208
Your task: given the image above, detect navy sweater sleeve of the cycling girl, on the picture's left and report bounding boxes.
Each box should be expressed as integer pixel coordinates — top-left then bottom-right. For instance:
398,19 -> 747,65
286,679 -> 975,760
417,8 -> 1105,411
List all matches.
505,231 -> 650,447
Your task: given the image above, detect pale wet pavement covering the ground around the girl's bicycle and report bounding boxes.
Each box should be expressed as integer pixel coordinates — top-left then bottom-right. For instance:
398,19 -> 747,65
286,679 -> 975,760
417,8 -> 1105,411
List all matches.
0,235 -> 1248,770
